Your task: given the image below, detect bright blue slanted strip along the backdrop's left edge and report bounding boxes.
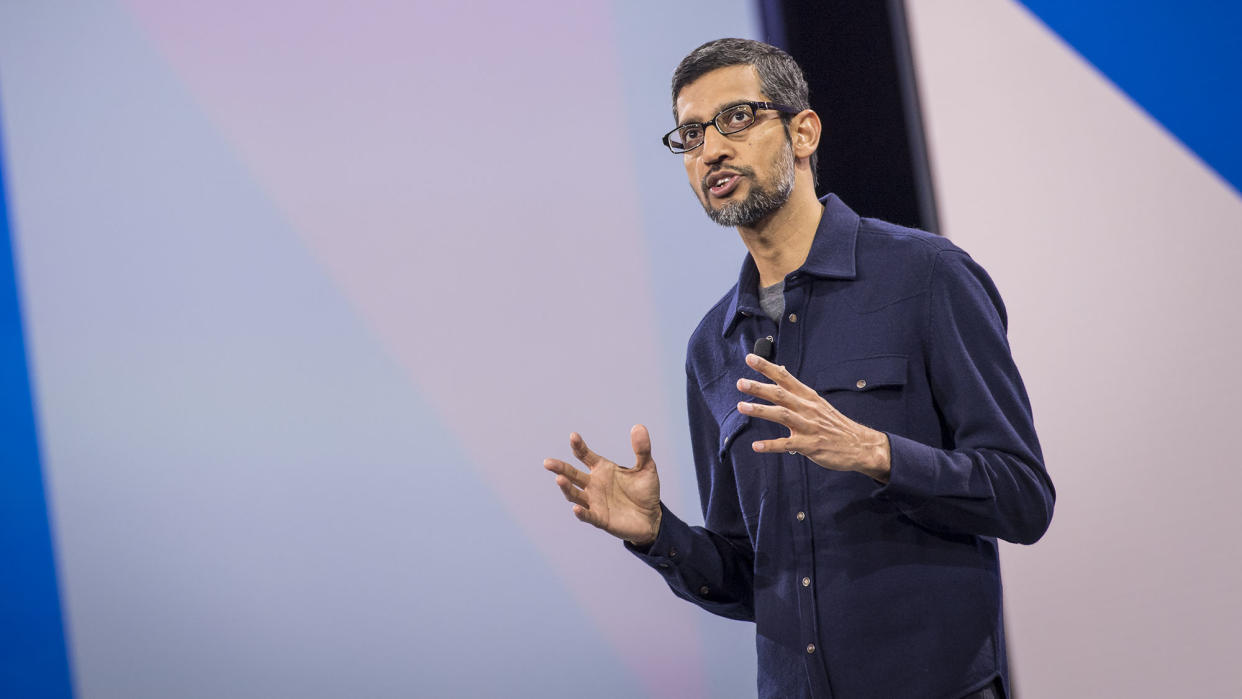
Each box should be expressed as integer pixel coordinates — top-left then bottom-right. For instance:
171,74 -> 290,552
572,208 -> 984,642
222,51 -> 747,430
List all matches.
0,94 -> 72,698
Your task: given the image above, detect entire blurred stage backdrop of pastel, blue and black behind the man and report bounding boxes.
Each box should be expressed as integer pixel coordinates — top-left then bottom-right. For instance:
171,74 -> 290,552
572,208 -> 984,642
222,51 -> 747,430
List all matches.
0,0 -> 1242,698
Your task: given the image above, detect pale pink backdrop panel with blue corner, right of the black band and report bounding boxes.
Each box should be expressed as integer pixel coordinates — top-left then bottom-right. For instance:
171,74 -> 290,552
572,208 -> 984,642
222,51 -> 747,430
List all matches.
907,0 -> 1242,699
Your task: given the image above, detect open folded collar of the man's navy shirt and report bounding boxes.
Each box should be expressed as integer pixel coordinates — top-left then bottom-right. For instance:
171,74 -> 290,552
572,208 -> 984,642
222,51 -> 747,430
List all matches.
720,194 -> 858,336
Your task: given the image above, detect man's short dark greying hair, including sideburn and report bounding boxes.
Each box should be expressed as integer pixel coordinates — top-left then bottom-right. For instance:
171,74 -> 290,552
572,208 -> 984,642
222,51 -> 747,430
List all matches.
673,38 -> 820,183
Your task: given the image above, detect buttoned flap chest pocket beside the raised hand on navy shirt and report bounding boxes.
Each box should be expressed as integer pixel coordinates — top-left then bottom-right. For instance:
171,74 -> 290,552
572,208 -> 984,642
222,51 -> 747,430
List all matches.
811,354 -> 909,433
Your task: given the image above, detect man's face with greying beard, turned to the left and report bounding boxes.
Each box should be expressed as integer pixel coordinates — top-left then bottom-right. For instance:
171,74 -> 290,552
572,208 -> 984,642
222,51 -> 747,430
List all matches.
677,66 -> 794,226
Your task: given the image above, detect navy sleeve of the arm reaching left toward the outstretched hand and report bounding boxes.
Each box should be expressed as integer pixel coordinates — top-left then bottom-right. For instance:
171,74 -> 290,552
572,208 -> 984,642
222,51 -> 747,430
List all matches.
625,376 -> 755,621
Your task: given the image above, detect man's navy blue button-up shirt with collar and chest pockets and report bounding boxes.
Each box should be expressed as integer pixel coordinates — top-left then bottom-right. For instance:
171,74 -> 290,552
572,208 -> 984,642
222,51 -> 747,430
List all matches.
631,195 -> 1054,699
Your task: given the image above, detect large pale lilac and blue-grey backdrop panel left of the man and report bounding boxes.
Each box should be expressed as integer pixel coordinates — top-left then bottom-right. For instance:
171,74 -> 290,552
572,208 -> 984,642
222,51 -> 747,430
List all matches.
0,0 -> 758,698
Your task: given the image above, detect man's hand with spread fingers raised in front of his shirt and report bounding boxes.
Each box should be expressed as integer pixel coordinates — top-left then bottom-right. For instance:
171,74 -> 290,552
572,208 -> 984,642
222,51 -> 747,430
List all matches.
738,354 -> 892,483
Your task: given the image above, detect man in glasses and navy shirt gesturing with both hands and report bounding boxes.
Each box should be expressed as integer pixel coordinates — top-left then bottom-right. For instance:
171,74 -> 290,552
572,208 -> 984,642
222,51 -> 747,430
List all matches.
544,38 -> 1054,699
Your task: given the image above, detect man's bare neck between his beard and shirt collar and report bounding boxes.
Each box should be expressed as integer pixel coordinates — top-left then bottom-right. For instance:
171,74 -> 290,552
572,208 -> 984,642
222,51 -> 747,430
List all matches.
738,187 -> 823,287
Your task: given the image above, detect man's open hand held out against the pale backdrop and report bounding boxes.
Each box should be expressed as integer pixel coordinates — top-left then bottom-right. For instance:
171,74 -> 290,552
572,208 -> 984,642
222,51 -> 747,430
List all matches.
544,425 -> 661,546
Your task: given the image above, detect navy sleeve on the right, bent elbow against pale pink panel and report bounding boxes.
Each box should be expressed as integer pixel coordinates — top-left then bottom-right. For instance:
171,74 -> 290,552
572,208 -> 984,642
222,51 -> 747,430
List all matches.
874,250 -> 1056,544
